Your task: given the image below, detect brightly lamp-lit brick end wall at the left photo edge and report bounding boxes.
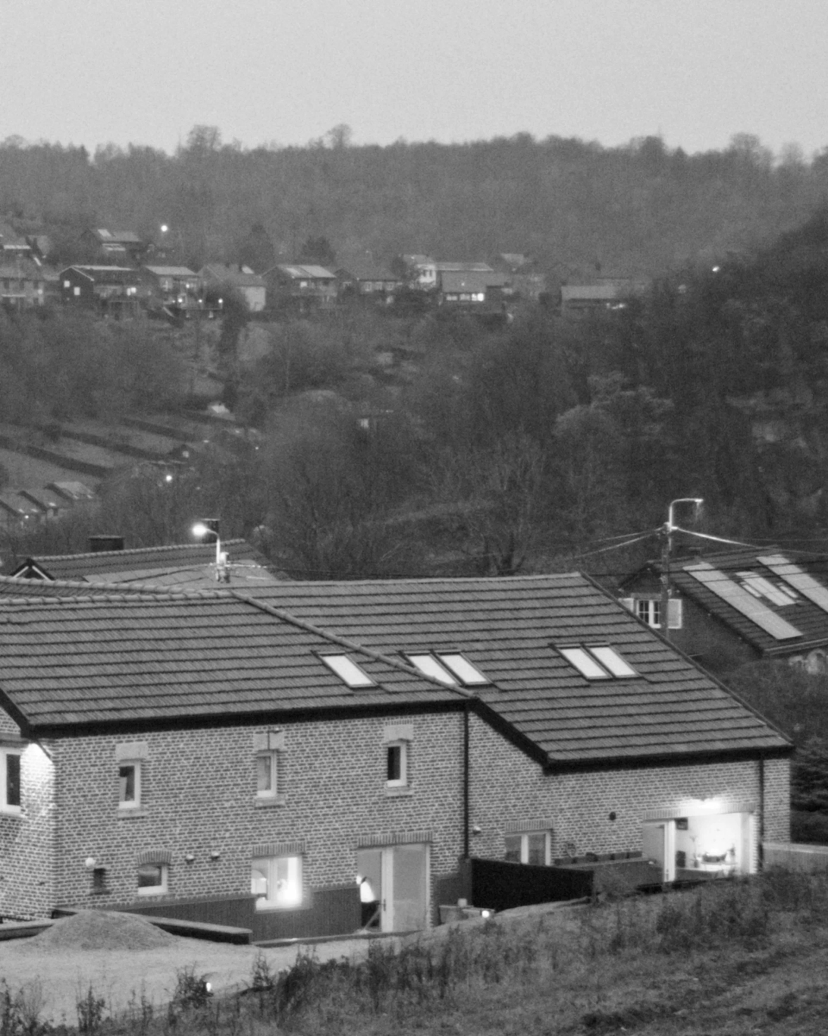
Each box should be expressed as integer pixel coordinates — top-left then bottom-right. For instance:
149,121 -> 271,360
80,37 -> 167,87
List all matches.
0,710 -> 55,920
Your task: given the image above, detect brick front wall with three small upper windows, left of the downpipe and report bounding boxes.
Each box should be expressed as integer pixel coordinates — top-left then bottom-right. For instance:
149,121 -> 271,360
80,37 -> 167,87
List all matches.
50,714 -> 462,924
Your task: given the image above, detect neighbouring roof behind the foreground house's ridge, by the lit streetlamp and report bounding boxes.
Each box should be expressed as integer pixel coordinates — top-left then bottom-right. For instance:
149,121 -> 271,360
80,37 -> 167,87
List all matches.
0,540 -> 277,594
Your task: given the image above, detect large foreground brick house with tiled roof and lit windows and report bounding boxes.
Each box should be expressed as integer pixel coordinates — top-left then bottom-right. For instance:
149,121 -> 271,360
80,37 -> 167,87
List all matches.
0,575 -> 791,939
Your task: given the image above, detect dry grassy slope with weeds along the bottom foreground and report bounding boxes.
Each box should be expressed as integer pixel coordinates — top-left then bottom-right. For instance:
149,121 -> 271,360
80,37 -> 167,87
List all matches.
0,873 -> 828,1036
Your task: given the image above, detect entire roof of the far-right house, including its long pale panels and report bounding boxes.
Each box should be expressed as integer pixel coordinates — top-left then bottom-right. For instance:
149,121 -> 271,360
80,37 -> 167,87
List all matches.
624,547 -> 828,656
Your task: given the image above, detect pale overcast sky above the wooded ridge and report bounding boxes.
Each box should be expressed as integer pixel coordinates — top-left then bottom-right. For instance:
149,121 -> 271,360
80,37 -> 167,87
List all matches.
6,0 -> 828,155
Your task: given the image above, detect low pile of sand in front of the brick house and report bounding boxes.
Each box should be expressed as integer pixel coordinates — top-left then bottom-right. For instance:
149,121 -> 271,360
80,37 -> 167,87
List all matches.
26,910 -> 176,953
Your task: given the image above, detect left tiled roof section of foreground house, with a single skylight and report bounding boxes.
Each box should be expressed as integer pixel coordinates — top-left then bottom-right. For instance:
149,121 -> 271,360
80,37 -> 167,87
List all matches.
0,593 -> 462,736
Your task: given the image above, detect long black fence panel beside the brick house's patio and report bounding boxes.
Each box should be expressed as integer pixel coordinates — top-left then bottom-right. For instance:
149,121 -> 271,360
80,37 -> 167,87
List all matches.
464,857 -> 593,911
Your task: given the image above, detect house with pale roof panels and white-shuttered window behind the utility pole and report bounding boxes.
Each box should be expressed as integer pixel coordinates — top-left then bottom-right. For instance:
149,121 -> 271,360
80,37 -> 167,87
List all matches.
619,547 -> 828,673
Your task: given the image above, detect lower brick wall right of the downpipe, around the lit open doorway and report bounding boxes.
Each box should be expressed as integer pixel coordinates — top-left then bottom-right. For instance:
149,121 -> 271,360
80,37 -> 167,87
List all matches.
469,717 -> 790,861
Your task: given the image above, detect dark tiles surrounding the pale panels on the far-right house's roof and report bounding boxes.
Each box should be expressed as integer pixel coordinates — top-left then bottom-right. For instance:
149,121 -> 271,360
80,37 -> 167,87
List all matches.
663,547 -> 828,655
